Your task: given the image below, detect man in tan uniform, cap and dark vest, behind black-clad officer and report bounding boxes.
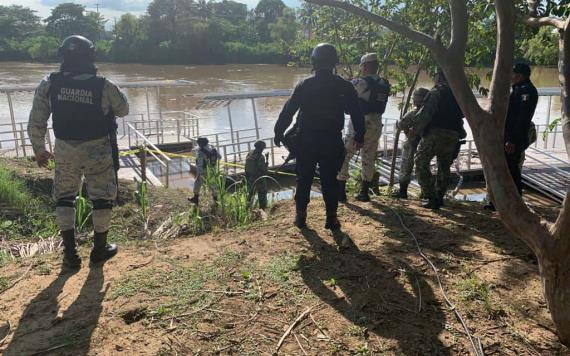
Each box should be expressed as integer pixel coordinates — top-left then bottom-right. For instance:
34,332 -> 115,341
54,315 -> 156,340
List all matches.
337,53 -> 390,202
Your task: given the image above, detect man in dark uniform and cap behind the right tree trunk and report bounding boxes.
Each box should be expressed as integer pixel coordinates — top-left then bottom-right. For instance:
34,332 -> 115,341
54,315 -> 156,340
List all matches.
484,63 -> 538,210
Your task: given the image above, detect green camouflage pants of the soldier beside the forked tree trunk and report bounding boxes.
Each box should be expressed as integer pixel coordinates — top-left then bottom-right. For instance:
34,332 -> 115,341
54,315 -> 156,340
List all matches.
415,129 -> 459,199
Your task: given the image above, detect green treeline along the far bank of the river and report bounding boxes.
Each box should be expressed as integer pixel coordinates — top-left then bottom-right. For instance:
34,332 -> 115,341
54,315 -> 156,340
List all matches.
0,0 -> 557,66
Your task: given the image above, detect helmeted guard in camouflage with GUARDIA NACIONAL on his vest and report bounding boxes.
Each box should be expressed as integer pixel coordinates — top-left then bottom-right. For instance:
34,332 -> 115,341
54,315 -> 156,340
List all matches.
28,36 -> 129,268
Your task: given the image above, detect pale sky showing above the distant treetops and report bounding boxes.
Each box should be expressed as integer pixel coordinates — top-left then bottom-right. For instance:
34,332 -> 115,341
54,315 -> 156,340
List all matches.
0,0 -> 299,24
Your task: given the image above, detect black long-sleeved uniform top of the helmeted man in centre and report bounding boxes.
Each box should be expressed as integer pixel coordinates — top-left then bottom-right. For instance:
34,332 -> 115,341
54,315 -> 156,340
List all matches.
275,70 -> 365,144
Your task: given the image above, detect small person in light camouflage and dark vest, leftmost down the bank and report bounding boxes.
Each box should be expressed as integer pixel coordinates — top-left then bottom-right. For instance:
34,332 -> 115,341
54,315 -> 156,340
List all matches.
188,137 -> 222,205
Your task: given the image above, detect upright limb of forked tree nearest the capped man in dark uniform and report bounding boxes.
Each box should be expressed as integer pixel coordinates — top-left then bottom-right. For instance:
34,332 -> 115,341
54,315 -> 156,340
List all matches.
489,0 -> 515,119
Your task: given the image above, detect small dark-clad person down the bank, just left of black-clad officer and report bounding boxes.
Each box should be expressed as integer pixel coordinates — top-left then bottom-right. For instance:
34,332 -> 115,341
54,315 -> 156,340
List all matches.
245,141 -> 269,209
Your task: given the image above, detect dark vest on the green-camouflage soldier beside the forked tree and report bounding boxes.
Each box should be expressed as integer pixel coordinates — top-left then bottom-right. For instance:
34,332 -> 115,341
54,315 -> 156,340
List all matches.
425,85 -> 464,133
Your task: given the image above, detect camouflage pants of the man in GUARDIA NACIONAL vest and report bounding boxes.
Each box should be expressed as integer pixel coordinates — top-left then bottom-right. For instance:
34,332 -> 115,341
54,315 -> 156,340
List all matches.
53,137 -> 117,232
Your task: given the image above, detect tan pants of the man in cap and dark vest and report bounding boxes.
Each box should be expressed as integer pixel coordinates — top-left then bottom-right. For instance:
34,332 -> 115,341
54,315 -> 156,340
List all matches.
337,114 -> 382,182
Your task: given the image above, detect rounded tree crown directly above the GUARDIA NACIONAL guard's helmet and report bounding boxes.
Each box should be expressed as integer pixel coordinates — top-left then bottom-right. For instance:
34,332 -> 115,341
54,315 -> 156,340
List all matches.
45,3 -> 104,40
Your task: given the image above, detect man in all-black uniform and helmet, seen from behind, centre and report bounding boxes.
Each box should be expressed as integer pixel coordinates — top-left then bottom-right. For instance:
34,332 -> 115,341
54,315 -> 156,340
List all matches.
275,43 -> 365,230
